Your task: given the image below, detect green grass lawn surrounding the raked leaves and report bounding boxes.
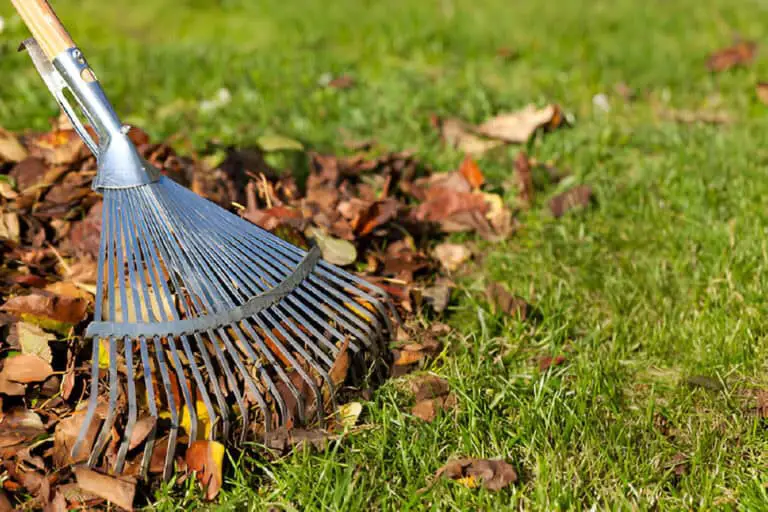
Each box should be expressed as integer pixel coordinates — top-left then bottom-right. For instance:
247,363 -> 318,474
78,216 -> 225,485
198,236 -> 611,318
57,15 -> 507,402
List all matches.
0,0 -> 768,510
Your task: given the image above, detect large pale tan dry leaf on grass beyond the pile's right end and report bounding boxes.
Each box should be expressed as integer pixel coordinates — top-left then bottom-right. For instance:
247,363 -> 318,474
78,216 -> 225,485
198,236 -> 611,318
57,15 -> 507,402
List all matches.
476,105 -> 565,143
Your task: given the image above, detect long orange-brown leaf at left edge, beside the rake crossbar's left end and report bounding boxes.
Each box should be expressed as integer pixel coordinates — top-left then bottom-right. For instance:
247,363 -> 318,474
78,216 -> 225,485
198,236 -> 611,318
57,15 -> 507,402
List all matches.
0,291 -> 88,327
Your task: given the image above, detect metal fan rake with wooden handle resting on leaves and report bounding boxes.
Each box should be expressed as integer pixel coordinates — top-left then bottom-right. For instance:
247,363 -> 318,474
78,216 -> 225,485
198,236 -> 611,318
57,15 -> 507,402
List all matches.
12,0 -> 396,479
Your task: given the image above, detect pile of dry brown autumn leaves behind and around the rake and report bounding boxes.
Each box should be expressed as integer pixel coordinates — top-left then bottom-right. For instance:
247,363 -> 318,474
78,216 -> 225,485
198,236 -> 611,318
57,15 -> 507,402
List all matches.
0,103 -> 591,510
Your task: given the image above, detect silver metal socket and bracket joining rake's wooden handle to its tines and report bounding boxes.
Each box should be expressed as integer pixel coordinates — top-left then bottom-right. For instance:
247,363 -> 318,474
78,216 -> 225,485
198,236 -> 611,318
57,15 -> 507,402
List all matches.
24,39 -> 160,190
